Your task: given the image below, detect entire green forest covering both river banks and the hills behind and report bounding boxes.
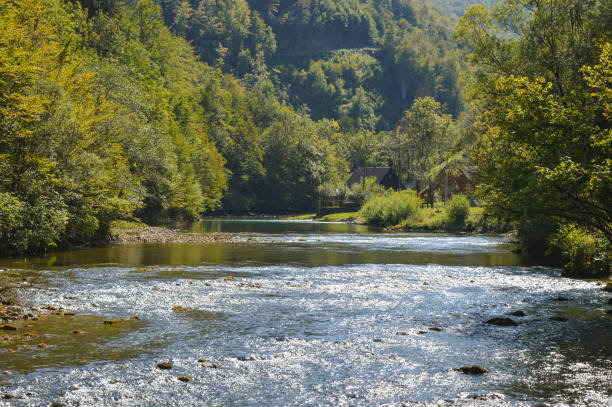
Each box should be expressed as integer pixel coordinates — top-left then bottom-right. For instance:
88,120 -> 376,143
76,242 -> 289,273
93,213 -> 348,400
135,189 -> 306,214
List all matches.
0,0 -> 612,269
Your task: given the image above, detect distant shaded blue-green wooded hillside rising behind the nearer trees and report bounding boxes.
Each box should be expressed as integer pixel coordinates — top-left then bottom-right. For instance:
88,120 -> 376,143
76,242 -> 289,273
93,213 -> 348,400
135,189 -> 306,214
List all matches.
161,0 -> 462,132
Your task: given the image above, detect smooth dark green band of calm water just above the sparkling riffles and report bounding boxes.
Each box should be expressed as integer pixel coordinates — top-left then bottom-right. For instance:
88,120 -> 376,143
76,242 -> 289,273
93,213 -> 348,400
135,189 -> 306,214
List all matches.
0,242 -> 523,269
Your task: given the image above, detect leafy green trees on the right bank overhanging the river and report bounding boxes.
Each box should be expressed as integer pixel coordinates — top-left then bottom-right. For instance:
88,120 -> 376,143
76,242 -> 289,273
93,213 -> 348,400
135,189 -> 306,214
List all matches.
457,0 -> 612,275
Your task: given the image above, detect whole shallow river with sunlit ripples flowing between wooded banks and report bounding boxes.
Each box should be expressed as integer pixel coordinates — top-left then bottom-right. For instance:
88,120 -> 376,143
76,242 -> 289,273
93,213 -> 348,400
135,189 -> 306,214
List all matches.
0,220 -> 612,406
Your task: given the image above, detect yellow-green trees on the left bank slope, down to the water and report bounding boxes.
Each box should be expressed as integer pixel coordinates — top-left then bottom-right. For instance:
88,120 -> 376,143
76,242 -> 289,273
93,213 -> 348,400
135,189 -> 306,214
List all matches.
0,0 -> 347,252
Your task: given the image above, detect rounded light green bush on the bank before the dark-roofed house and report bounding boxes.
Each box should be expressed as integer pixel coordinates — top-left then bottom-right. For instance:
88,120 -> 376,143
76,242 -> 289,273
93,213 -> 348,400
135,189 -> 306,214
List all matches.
361,191 -> 421,226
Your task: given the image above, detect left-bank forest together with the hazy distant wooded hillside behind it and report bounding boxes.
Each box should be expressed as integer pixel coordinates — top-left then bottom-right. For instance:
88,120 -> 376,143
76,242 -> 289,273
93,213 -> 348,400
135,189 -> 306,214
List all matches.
0,0 -> 468,252
